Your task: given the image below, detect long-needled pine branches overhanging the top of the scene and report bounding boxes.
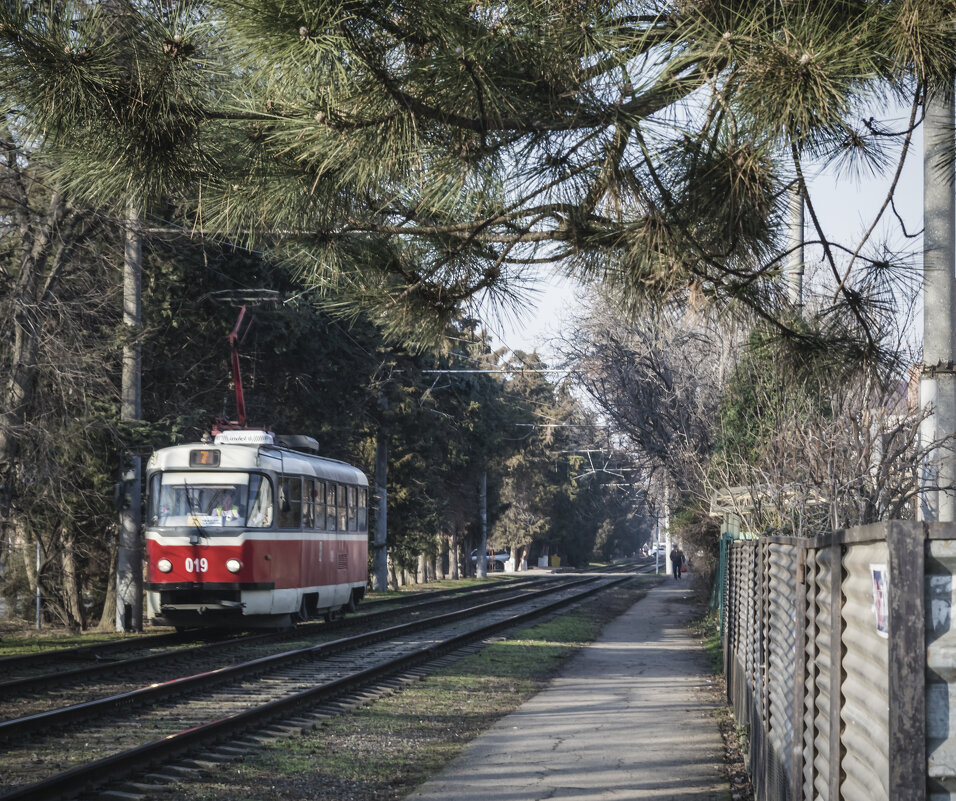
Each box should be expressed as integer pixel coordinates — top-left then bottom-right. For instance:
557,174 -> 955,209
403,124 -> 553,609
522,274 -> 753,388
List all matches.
0,0 -> 956,354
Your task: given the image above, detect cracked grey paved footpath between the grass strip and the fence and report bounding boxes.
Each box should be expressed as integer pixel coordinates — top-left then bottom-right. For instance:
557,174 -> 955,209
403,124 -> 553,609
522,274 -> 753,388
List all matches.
406,577 -> 730,801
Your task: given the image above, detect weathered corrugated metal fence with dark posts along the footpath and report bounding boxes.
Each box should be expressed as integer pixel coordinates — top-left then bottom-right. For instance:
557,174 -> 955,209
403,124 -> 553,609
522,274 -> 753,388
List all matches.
719,522 -> 956,801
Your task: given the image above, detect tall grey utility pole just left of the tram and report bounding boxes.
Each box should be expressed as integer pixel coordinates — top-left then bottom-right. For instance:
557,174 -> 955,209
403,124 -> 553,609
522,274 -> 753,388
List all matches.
116,204 -> 143,631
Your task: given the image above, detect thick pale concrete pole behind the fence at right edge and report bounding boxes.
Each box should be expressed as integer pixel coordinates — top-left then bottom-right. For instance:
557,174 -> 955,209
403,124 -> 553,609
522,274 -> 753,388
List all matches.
920,86 -> 956,522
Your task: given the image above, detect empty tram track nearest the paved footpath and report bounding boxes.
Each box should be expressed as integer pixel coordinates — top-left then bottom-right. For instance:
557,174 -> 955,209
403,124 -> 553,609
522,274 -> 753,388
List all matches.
0,575 -> 648,801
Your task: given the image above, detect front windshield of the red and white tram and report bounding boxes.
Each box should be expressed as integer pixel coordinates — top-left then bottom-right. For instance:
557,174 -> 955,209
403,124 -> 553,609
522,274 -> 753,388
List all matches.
148,471 -> 272,529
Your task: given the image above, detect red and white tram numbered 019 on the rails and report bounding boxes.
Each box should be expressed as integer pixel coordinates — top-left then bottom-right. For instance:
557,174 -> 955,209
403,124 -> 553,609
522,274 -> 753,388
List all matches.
146,430 -> 368,628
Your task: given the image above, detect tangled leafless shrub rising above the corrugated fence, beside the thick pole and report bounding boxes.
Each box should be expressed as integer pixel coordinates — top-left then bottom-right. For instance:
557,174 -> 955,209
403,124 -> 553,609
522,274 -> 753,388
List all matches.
701,354 -> 938,535
